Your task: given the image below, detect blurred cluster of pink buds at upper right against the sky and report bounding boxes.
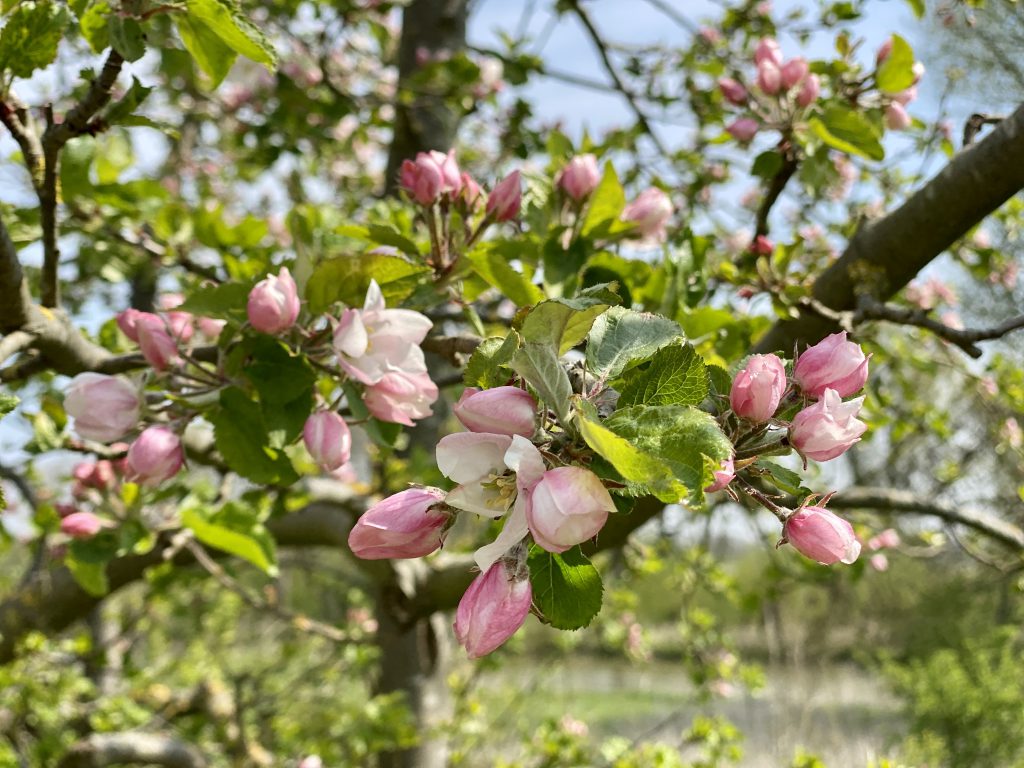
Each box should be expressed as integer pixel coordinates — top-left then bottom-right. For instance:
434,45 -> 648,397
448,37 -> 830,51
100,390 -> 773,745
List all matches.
718,38 -> 821,143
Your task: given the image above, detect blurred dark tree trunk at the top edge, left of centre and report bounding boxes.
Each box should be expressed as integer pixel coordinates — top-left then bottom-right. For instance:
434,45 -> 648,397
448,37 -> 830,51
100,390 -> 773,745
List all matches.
385,0 -> 469,194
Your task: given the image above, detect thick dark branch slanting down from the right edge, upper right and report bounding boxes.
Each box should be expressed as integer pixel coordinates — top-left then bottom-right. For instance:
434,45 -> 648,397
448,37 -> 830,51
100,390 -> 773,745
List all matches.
753,99 -> 1024,352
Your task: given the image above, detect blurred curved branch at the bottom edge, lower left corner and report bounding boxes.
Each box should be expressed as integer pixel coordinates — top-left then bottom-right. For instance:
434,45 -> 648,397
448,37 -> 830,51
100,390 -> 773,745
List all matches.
57,731 -> 207,768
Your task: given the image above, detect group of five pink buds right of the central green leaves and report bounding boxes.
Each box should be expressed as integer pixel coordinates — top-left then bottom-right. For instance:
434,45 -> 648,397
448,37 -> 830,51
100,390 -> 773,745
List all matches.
706,331 -> 868,564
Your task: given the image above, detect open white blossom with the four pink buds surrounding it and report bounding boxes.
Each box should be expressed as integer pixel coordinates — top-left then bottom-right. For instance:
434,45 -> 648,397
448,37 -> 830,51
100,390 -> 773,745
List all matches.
349,386 -> 614,658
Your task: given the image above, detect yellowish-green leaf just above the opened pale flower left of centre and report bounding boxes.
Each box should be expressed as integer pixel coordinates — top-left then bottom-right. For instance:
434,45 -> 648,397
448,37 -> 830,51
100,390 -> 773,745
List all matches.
306,252 -> 429,314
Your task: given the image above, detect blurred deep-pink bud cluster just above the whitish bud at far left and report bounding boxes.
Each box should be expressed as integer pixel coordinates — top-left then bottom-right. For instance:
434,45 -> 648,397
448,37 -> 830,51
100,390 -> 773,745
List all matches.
117,294 -> 224,371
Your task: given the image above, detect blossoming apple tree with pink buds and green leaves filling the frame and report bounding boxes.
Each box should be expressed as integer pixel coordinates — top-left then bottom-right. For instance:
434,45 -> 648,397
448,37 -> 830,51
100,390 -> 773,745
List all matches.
0,0 -> 1024,768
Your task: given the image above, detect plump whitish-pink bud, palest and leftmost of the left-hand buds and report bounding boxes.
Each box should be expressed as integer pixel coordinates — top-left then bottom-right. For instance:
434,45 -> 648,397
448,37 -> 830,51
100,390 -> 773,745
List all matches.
65,373 -> 140,442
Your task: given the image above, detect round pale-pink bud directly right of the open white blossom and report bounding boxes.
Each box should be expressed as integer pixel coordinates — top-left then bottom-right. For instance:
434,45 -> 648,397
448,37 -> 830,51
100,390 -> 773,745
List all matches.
526,467 -> 615,552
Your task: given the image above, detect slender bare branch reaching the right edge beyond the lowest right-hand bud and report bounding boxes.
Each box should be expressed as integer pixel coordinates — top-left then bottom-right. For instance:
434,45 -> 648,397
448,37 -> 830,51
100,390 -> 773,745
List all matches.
828,487 -> 1024,551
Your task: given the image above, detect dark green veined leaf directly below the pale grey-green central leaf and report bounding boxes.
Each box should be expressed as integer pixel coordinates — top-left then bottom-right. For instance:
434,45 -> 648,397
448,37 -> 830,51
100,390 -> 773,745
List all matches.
618,344 -> 709,408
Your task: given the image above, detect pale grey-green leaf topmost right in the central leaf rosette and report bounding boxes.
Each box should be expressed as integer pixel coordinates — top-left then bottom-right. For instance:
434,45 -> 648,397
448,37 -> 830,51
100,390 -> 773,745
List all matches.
587,307 -> 683,379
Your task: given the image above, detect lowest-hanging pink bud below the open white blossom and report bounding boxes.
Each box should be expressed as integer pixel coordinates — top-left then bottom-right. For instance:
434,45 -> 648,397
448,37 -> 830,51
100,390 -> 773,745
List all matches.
455,560 -> 534,658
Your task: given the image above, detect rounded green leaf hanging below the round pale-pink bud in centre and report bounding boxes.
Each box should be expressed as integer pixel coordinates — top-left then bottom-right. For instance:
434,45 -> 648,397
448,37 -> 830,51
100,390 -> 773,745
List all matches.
527,546 -> 604,630
